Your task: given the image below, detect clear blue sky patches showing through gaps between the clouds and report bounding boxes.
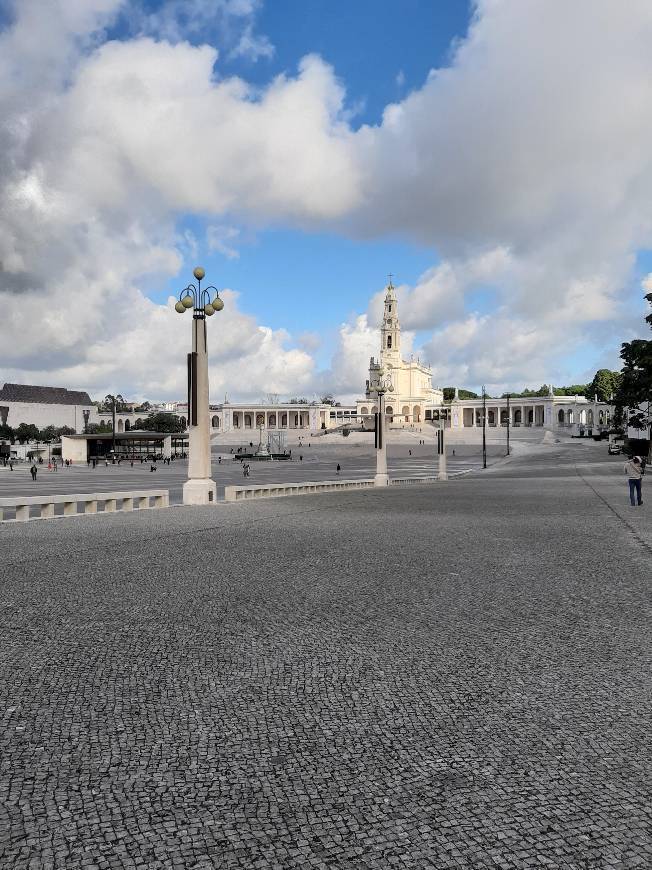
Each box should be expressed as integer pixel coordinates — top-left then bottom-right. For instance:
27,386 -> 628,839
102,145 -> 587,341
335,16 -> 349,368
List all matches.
149,0 -> 474,366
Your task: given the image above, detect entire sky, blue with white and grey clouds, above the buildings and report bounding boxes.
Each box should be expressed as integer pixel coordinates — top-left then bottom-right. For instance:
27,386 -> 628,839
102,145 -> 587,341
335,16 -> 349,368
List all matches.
0,0 -> 652,401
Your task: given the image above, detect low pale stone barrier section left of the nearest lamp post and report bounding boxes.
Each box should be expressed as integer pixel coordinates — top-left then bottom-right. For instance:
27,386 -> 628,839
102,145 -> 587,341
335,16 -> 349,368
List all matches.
0,489 -> 170,522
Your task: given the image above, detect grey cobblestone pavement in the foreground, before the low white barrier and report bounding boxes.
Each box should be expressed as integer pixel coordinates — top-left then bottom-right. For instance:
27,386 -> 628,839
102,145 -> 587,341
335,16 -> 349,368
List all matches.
0,446 -> 652,870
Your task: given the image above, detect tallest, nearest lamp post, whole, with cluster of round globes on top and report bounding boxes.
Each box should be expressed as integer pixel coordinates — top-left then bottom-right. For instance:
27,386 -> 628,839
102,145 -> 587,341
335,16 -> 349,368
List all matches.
174,266 -> 224,504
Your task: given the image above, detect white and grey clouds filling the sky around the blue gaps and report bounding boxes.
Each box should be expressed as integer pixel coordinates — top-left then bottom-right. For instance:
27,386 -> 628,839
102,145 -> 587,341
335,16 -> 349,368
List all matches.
0,0 -> 652,394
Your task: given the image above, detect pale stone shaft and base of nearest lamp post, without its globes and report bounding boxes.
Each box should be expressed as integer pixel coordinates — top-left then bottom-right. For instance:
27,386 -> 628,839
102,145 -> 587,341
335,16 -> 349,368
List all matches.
183,316 -> 217,504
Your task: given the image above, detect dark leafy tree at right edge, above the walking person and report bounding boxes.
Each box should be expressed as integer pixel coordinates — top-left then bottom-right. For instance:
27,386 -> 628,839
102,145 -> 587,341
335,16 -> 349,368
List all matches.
614,293 -> 652,449
